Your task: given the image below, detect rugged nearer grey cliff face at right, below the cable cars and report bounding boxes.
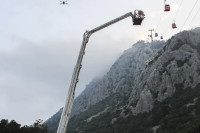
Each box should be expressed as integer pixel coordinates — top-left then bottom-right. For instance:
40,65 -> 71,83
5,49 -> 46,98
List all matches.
128,29 -> 200,115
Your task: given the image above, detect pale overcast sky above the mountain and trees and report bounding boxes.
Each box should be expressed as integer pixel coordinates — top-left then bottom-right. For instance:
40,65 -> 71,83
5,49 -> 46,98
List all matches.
0,0 -> 200,125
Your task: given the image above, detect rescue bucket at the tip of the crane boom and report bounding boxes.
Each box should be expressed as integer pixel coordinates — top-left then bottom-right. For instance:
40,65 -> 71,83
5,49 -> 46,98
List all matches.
133,10 -> 145,25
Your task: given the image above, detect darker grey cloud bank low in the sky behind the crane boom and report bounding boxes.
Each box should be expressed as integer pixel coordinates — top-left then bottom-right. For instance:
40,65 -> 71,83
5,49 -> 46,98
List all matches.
0,37 -> 129,124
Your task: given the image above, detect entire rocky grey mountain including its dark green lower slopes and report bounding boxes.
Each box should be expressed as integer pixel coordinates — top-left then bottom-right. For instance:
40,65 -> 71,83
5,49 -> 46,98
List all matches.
46,28 -> 200,133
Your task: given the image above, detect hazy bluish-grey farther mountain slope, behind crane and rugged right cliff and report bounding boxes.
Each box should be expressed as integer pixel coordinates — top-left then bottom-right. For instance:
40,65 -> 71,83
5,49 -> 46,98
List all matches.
46,41 -> 164,130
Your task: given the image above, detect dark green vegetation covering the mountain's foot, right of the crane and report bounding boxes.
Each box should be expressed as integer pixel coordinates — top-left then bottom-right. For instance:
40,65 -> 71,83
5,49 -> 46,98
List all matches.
67,85 -> 200,133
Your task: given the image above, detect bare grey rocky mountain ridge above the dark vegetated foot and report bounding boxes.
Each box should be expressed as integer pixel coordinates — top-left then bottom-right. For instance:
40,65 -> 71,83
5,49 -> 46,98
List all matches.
46,28 -> 200,132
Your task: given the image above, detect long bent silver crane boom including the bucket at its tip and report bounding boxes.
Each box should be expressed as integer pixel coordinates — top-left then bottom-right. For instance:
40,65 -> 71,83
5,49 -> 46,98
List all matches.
57,11 -> 144,133
